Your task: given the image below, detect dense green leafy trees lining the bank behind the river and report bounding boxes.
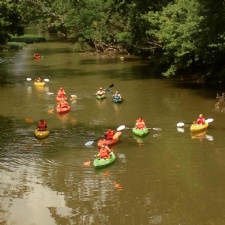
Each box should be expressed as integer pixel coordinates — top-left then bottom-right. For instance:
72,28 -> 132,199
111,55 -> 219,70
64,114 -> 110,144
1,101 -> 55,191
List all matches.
0,0 -> 225,82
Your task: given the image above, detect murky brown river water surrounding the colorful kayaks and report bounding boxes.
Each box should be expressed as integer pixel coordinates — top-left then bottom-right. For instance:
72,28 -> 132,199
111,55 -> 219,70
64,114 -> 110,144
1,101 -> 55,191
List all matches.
0,32 -> 225,225
